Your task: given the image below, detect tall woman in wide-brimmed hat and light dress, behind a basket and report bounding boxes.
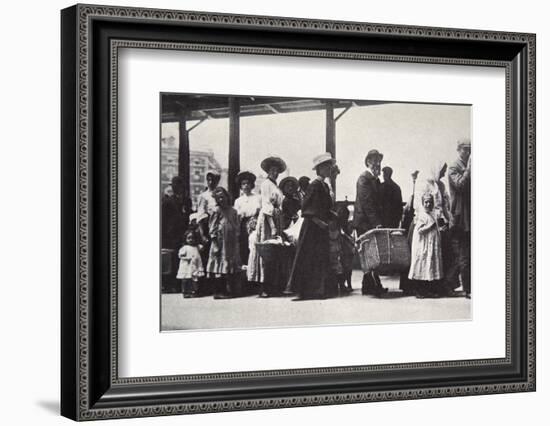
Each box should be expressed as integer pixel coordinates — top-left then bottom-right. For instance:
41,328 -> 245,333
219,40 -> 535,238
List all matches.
252,157 -> 286,297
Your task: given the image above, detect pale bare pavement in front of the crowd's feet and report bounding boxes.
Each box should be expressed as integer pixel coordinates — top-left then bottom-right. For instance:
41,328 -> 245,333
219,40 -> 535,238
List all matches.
161,271 -> 471,331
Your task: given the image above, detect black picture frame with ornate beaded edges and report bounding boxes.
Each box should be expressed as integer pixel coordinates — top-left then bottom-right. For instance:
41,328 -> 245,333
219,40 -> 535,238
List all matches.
61,5 -> 536,420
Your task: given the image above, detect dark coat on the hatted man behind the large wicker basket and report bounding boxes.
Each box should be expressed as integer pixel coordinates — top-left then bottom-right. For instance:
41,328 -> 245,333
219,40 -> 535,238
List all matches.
353,170 -> 382,235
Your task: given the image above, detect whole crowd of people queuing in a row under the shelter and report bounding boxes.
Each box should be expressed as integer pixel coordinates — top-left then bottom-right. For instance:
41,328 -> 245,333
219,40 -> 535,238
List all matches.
162,139 -> 471,301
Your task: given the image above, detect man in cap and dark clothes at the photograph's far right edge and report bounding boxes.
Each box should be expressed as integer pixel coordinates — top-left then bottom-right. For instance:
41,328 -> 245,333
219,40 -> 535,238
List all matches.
446,138 -> 472,298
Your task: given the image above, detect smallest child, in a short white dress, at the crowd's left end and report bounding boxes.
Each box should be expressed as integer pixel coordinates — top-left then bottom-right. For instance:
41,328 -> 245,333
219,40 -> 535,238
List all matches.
176,230 -> 204,299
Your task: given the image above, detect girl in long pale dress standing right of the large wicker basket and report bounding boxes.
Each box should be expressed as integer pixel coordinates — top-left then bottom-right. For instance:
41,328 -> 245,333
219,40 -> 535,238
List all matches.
409,193 -> 443,298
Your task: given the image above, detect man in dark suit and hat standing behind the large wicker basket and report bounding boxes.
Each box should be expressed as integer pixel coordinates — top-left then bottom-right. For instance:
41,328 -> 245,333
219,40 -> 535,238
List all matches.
353,149 -> 388,296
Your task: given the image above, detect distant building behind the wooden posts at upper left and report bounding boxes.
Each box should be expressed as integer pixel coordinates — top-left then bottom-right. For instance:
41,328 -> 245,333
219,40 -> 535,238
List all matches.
160,136 -> 228,209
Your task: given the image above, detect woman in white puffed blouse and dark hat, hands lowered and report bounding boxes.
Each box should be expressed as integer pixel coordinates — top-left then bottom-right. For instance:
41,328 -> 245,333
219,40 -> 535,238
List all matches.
234,170 -> 260,272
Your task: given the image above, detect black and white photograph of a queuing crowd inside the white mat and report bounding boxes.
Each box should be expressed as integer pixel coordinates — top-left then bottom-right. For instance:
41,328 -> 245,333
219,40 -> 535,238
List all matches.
160,93 -> 476,331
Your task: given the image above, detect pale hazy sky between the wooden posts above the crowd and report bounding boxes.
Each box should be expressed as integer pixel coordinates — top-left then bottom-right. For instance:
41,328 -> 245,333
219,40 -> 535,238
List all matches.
163,103 -> 471,200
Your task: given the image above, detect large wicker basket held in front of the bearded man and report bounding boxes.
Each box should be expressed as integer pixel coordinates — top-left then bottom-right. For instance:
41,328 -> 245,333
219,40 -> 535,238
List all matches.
356,228 -> 411,274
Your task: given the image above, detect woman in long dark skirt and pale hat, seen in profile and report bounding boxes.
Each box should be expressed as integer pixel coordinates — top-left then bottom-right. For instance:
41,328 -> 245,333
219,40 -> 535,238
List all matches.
289,153 -> 336,301
